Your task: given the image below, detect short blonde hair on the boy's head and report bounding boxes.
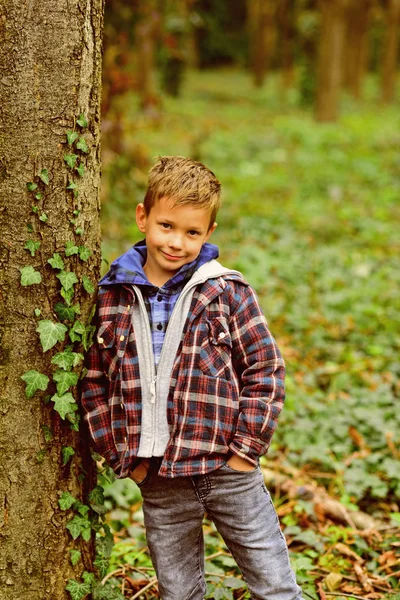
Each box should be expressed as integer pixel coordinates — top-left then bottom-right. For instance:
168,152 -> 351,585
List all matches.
143,156 -> 221,227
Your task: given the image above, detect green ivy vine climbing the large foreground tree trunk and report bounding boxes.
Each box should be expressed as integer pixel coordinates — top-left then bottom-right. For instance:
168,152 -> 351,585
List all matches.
20,114 -> 118,600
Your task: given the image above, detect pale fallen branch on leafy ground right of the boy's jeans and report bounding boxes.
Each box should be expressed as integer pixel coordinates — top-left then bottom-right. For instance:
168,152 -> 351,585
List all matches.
261,467 -> 380,529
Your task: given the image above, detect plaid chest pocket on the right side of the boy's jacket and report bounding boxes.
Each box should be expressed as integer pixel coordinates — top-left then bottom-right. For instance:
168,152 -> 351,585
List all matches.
199,317 -> 232,380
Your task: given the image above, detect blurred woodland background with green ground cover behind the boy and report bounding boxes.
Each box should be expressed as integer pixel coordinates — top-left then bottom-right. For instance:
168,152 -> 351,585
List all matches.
97,0 -> 400,600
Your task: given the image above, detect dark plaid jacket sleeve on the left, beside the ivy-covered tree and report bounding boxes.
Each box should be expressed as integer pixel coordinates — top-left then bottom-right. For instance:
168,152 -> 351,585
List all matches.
81,310 -> 121,474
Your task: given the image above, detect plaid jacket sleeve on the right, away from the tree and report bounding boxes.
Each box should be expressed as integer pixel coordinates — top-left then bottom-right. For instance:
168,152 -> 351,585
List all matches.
229,285 -> 285,465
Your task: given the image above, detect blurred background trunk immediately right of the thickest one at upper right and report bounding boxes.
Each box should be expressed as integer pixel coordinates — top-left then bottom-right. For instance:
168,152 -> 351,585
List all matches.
343,0 -> 371,99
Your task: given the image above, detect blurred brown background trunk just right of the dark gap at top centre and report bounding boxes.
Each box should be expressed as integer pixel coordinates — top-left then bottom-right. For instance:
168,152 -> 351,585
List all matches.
247,0 -> 275,87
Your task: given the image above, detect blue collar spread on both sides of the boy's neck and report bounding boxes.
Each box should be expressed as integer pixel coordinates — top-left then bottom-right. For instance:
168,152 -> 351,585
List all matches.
99,240 -> 219,287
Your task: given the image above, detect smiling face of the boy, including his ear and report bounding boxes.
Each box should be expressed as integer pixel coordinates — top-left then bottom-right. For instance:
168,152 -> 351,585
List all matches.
136,197 -> 217,287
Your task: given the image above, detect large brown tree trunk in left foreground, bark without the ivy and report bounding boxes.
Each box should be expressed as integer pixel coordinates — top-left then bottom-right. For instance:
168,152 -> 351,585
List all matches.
0,0 -> 103,600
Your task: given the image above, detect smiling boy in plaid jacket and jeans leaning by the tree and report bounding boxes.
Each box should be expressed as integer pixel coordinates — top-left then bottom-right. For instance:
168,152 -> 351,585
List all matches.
82,156 -> 301,600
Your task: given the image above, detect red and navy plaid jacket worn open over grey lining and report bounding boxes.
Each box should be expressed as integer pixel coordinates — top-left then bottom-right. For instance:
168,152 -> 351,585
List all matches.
82,276 -> 284,477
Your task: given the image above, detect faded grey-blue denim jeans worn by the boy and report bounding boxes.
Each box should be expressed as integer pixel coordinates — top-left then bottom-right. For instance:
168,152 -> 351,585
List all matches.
139,463 -> 302,600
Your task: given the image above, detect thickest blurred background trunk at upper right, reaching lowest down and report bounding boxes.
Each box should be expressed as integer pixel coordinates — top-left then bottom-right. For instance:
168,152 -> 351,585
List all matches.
315,0 -> 348,121
